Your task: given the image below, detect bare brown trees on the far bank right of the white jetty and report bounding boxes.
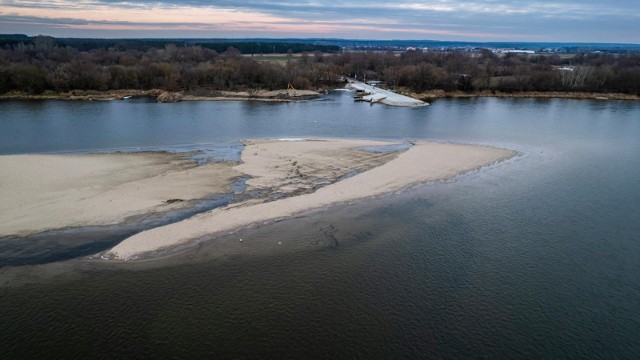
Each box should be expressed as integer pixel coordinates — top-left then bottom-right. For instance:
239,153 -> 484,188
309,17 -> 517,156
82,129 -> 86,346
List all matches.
332,50 -> 640,95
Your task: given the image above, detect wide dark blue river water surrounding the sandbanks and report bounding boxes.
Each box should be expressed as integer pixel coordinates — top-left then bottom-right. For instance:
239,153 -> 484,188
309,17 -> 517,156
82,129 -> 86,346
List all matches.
0,91 -> 640,358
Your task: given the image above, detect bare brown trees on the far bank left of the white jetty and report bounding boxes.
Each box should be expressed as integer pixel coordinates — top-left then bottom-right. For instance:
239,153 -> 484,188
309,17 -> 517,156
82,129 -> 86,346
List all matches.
0,43 -> 341,94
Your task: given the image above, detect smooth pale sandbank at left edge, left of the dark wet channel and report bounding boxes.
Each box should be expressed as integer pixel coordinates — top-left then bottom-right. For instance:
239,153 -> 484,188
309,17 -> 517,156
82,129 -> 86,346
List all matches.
0,153 -> 240,236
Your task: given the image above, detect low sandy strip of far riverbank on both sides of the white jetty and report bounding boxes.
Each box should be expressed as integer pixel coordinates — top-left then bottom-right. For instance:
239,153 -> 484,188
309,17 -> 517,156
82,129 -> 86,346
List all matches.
0,89 -> 640,102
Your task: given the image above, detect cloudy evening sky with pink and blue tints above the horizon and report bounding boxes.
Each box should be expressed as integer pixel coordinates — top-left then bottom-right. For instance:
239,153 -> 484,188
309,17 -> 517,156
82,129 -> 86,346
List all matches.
0,0 -> 640,44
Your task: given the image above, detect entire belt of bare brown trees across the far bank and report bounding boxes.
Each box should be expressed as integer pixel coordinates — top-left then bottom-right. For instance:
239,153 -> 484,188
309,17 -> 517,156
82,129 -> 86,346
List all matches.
0,37 -> 640,95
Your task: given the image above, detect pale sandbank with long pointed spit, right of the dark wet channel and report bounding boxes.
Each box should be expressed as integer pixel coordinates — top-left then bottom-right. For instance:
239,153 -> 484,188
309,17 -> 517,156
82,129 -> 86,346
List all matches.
106,140 -> 516,259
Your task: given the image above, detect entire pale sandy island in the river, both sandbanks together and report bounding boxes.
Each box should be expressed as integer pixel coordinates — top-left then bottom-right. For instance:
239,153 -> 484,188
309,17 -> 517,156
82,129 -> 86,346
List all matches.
0,139 -> 515,260
